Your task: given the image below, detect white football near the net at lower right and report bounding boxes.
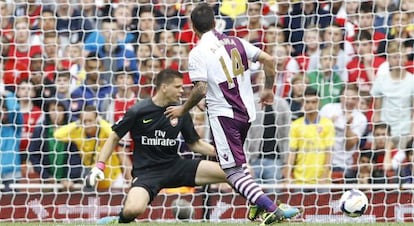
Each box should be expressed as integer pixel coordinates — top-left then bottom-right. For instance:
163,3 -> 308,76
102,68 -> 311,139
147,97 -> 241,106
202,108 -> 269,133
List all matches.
339,189 -> 368,217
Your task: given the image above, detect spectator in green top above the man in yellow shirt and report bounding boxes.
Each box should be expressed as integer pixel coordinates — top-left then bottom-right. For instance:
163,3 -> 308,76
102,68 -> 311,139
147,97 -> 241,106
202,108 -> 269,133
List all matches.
307,48 -> 344,107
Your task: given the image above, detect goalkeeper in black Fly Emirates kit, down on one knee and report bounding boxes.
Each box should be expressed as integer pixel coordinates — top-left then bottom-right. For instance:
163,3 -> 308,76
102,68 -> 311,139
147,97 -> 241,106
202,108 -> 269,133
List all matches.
86,69 -> 227,224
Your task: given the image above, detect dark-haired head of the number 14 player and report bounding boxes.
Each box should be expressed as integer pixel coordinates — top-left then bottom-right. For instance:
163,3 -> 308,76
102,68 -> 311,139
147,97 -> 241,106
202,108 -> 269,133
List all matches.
191,3 -> 215,34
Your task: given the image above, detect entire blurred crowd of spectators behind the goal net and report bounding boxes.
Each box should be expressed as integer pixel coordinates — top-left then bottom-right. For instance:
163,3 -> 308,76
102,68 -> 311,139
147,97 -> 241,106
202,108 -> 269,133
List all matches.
0,0 -> 414,191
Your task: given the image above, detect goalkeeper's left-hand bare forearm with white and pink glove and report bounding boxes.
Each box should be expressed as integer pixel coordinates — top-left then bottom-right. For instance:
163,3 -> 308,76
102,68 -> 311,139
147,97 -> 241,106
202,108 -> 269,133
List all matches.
85,132 -> 119,187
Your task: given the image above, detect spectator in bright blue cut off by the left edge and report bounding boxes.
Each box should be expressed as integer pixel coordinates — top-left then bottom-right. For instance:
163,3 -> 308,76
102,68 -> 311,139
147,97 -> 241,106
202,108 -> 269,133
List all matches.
0,91 -> 23,193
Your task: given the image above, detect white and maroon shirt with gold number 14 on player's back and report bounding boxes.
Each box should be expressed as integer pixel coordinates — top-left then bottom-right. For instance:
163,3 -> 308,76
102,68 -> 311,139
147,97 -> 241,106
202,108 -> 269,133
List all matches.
189,31 -> 261,122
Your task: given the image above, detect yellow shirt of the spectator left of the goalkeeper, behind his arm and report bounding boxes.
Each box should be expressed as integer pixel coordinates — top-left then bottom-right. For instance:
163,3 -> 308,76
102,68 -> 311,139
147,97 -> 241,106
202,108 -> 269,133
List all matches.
54,115 -> 122,189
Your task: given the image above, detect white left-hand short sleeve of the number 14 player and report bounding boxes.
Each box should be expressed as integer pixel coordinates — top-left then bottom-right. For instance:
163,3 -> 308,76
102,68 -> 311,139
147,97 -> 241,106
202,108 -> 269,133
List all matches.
188,49 -> 207,82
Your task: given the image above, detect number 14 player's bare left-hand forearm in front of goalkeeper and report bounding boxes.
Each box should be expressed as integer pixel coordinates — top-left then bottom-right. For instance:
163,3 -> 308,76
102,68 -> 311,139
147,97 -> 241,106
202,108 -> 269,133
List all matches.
164,81 -> 207,118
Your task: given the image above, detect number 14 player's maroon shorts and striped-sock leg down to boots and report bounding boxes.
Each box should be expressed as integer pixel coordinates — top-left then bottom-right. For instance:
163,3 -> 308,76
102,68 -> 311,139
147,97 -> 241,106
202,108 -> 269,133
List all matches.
210,117 -> 299,224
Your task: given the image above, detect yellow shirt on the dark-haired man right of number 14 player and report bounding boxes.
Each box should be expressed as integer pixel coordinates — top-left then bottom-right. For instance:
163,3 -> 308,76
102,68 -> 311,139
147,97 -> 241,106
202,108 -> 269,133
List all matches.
290,117 -> 335,184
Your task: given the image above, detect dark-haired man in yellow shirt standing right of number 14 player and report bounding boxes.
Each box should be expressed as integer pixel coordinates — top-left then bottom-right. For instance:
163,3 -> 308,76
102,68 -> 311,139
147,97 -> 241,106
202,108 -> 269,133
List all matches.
283,87 -> 335,192
